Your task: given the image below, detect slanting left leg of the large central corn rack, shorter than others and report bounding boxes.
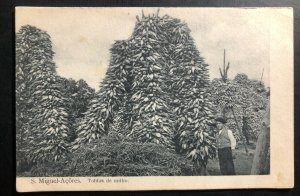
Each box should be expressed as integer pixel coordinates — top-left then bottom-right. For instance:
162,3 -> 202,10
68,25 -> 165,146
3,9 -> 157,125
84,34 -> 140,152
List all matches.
73,41 -> 130,146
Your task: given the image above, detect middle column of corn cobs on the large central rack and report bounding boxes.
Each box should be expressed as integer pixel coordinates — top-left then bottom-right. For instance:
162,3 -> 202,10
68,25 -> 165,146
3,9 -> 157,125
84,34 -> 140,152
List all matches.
128,13 -> 174,148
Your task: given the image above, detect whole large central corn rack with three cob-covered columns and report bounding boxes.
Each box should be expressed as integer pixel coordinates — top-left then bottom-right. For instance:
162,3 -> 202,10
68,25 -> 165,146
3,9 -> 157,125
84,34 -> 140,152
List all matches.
74,15 -> 215,165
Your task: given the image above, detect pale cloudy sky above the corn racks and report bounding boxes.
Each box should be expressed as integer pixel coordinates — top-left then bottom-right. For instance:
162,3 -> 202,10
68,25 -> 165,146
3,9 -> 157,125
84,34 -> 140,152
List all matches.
16,7 -> 270,90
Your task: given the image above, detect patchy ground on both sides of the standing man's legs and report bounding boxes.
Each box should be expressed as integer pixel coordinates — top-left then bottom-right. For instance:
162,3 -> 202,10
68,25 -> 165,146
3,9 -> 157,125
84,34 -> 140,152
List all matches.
207,143 -> 256,176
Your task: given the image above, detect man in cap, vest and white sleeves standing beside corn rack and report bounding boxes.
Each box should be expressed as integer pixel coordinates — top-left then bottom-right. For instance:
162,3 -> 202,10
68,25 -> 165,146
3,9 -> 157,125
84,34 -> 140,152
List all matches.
215,117 -> 236,175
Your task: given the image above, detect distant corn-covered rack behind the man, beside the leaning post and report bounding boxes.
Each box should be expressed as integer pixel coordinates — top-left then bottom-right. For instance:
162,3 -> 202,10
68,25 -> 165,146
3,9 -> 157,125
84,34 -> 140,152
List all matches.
210,74 -> 268,139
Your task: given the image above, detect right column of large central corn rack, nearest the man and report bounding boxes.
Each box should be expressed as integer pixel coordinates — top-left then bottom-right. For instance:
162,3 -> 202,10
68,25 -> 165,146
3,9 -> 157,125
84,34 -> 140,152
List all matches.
164,19 -> 216,174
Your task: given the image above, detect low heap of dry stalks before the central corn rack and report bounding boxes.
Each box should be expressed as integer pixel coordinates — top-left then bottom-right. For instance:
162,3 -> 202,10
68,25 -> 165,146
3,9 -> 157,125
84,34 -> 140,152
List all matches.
30,132 -> 192,176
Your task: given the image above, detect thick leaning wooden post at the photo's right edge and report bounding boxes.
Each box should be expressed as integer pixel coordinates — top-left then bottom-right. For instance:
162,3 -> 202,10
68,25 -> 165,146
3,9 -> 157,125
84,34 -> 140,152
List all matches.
251,103 -> 270,175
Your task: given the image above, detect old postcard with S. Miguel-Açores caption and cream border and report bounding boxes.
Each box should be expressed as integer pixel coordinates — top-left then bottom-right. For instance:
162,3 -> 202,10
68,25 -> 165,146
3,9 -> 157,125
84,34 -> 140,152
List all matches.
15,7 -> 294,192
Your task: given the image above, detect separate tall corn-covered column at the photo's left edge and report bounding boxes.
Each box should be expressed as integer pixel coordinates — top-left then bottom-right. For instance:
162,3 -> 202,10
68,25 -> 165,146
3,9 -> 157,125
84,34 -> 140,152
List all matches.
16,25 -> 69,162
